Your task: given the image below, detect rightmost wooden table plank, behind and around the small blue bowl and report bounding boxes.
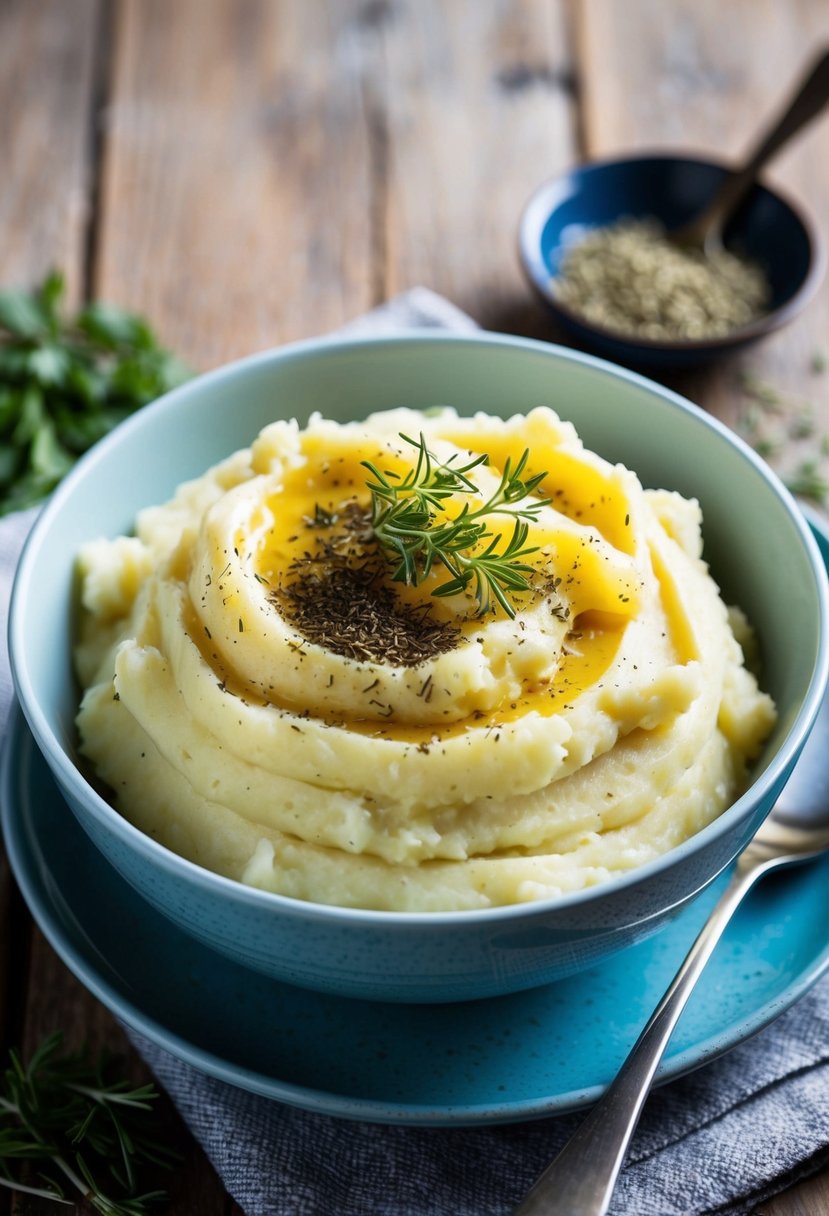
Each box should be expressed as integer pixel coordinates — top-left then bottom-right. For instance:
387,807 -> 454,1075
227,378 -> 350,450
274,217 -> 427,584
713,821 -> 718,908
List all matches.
574,0 -> 829,496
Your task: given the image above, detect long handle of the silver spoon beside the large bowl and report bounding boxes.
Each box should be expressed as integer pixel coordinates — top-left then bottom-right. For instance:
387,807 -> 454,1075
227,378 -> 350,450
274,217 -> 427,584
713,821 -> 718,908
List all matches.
513,862 -> 769,1216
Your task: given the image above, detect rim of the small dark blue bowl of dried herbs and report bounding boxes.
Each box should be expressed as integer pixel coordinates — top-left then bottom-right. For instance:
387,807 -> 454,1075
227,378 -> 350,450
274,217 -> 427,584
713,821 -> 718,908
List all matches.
518,148 -> 828,355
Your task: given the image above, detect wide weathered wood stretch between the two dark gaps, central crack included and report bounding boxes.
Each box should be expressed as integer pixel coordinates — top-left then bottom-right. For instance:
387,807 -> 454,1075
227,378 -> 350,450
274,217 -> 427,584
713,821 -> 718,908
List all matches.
96,0 -> 575,367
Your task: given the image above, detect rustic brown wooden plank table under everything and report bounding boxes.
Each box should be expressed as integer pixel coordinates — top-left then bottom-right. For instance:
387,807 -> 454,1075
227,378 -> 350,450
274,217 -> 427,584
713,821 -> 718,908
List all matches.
0,0 -> 829,1216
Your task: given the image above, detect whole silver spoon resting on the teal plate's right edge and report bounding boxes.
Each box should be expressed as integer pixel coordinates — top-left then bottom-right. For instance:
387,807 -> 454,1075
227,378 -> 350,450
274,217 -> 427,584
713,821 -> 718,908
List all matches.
513,696 -> 829,1216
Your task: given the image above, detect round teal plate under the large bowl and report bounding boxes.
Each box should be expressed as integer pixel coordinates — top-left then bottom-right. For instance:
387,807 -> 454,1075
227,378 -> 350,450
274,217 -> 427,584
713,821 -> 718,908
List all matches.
0,711 -> 829,1126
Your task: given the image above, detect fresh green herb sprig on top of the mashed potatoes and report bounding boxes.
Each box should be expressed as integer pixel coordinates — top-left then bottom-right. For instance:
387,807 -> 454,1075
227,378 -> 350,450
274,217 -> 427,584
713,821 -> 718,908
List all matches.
362,433 -> 549,618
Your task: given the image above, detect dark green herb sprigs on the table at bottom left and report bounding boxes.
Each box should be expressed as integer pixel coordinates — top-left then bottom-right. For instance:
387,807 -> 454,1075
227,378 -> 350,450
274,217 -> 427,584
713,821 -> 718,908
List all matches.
0,1035 -> 175,1216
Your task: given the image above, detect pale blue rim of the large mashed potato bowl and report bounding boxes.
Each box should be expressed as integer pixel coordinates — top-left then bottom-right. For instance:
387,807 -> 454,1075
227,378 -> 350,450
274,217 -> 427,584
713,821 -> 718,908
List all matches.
7,330 -> 829,929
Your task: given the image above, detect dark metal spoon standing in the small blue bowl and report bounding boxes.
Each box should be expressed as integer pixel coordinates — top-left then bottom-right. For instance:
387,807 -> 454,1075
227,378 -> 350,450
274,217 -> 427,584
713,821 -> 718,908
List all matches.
669,50 -> 829,254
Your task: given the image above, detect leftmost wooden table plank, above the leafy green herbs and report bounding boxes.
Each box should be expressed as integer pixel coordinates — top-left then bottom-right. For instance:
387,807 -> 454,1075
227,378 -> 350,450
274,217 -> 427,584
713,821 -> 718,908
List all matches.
0,7 -> 117,1212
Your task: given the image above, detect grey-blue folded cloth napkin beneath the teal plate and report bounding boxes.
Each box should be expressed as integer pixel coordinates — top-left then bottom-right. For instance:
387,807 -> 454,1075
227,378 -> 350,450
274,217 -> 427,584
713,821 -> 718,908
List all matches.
0,288 -> 829,1216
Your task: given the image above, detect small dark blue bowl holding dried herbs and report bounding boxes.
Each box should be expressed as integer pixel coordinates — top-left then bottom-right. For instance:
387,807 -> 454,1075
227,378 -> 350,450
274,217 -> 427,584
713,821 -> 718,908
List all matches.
519,154 -> 825,367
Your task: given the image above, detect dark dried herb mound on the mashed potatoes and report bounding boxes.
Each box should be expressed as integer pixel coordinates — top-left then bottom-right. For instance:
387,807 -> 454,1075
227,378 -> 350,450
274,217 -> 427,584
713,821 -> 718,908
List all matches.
272,503 -> 461,666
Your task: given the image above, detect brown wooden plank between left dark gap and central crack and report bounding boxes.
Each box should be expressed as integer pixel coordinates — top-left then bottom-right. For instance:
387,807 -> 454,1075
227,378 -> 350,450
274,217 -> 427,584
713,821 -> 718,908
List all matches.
95,0 -> 377,368
